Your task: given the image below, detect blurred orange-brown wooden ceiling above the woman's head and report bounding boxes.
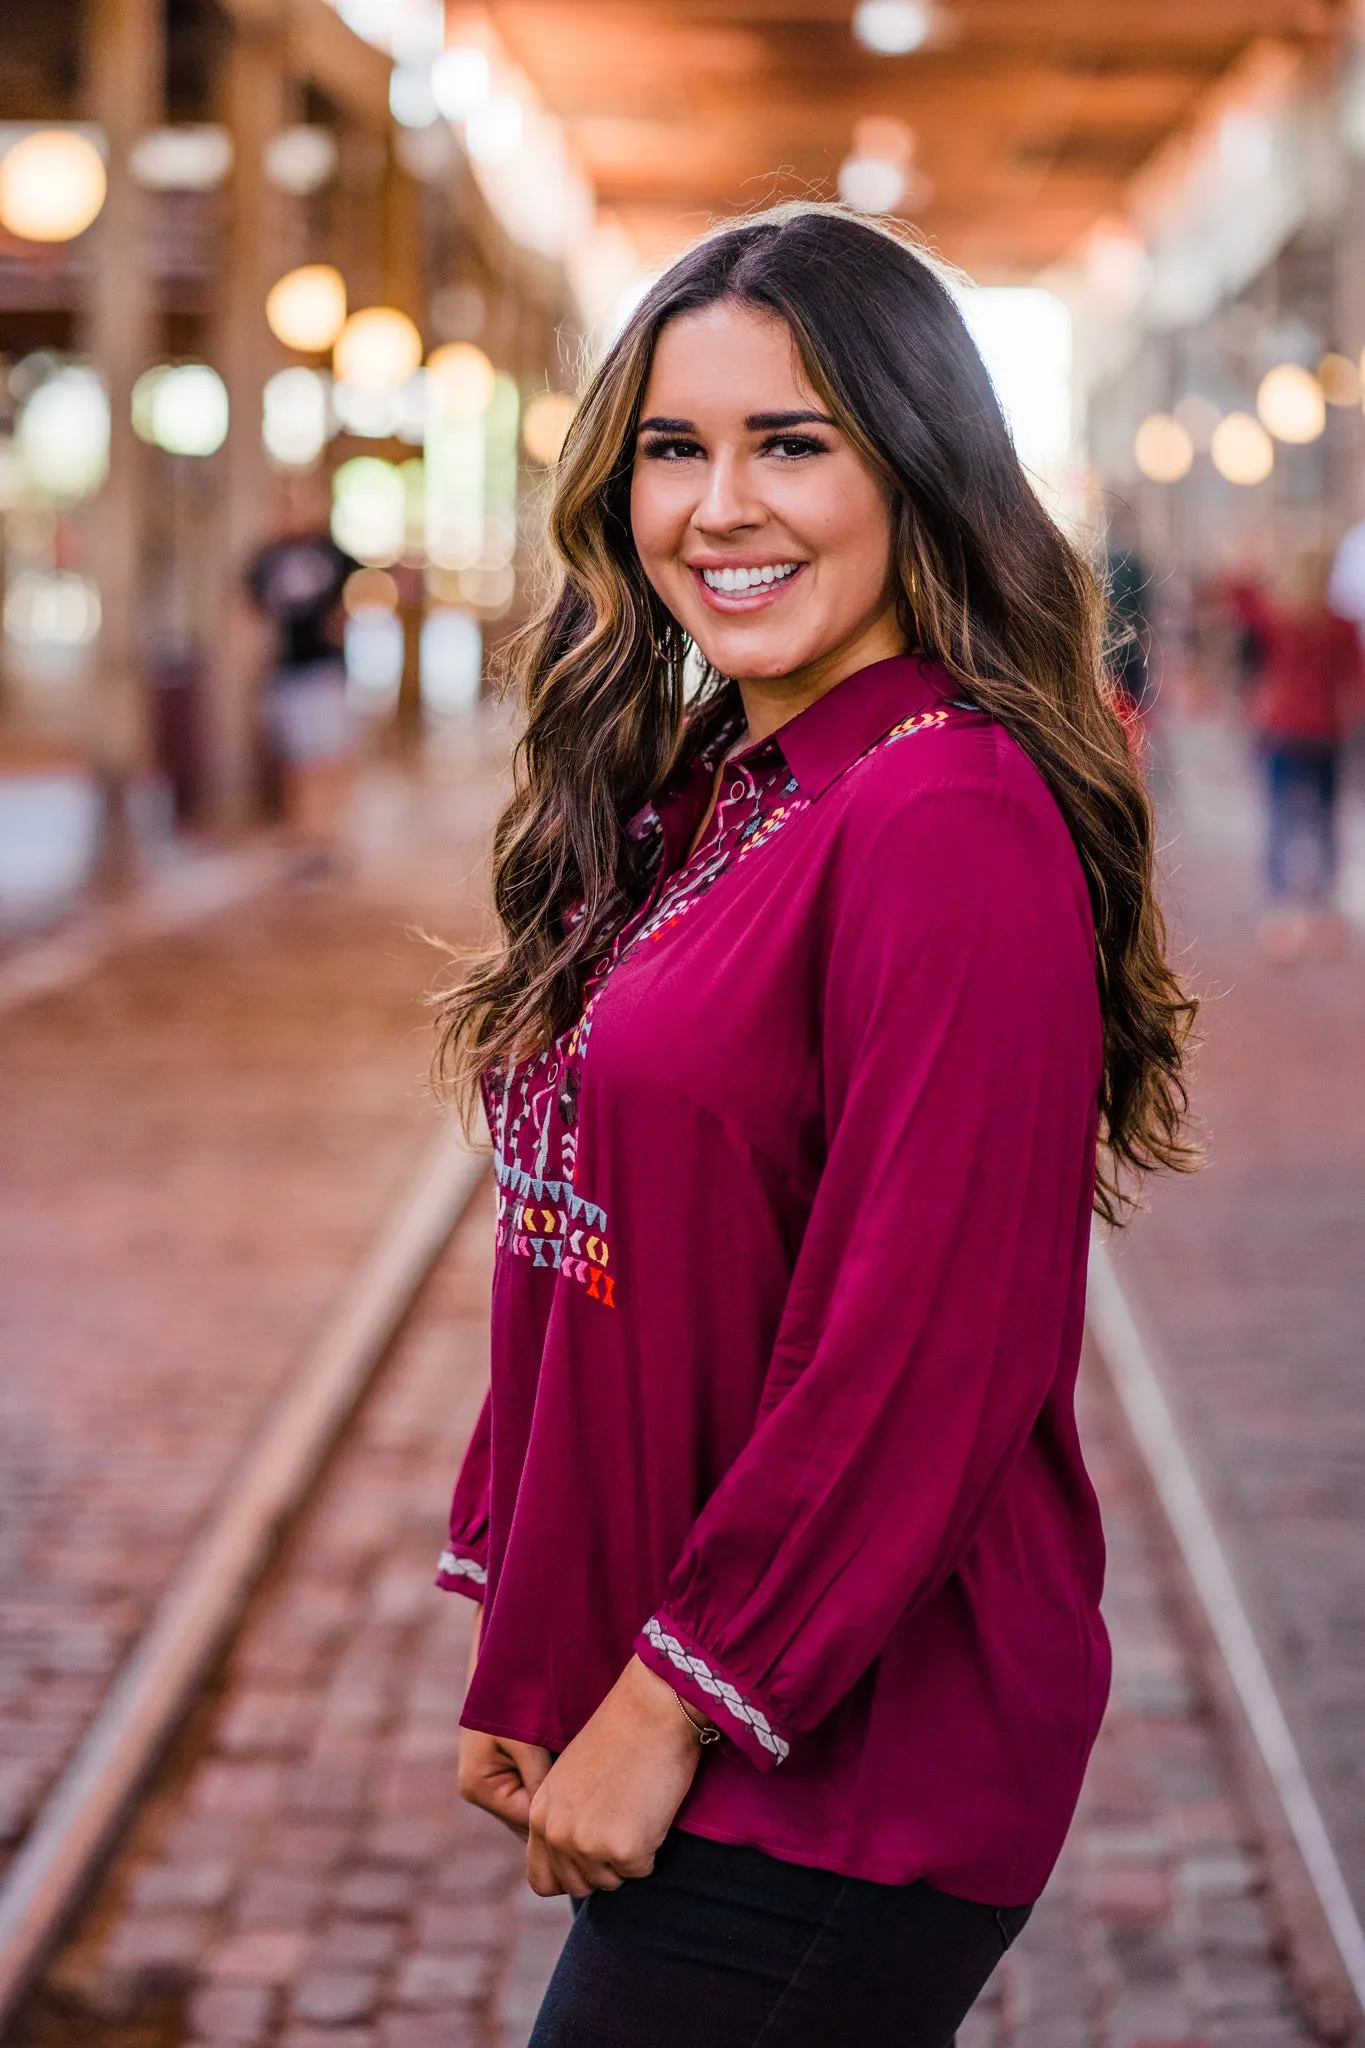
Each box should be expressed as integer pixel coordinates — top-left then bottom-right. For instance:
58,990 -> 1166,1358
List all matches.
480,0 -> 1342,279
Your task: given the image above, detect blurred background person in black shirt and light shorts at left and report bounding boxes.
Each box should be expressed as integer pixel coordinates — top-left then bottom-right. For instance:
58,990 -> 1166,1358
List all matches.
248,477 -> 358,874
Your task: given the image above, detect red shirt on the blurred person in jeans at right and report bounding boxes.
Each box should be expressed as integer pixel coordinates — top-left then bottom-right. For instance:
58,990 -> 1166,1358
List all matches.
1228,582 -> 1365,745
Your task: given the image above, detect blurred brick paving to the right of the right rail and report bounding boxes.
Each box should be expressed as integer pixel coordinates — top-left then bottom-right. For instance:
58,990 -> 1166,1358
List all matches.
1117,727 -> 1365,1911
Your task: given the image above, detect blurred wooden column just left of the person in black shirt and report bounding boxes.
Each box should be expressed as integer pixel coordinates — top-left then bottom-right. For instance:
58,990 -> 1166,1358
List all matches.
207,25 -> 291,831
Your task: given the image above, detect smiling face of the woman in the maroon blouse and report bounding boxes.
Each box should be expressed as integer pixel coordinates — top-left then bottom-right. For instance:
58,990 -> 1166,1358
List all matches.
630,301 -> 905,694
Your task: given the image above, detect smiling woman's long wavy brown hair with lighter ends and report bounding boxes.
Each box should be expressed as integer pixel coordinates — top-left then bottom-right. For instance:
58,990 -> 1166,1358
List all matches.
436,205 -> 1195,1223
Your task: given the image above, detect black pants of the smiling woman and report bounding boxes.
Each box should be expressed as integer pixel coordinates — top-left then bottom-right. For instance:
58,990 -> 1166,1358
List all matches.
530,1833 -> 1029,2048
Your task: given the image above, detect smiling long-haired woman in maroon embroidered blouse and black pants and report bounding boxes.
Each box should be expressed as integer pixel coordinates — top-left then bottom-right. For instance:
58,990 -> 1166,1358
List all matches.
431,207 -> 1189,2048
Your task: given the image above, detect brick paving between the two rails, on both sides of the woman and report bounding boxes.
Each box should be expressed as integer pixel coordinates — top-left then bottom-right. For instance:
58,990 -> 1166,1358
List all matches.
18,1196 -> 1312,2048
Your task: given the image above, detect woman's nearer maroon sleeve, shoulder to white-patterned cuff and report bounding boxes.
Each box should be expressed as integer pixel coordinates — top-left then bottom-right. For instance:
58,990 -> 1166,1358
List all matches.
636,778 -> 1099,1769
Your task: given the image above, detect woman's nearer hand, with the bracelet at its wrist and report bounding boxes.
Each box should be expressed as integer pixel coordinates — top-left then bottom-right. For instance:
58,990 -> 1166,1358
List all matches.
526,1657 -> 702,1898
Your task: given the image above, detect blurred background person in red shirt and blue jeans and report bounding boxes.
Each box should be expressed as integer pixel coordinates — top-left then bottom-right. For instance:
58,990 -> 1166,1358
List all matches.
1228,549 -> 1363,961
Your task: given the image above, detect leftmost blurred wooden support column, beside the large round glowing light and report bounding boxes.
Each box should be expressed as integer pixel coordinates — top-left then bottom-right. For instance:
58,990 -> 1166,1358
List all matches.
82,0 -> 166,887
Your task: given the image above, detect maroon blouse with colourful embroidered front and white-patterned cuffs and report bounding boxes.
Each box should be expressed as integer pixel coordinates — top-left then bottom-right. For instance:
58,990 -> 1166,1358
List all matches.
440,657 -> 1109,1905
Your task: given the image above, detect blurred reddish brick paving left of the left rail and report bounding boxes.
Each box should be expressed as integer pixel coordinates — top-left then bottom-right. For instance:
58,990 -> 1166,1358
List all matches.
0,737 -> 499,1875
